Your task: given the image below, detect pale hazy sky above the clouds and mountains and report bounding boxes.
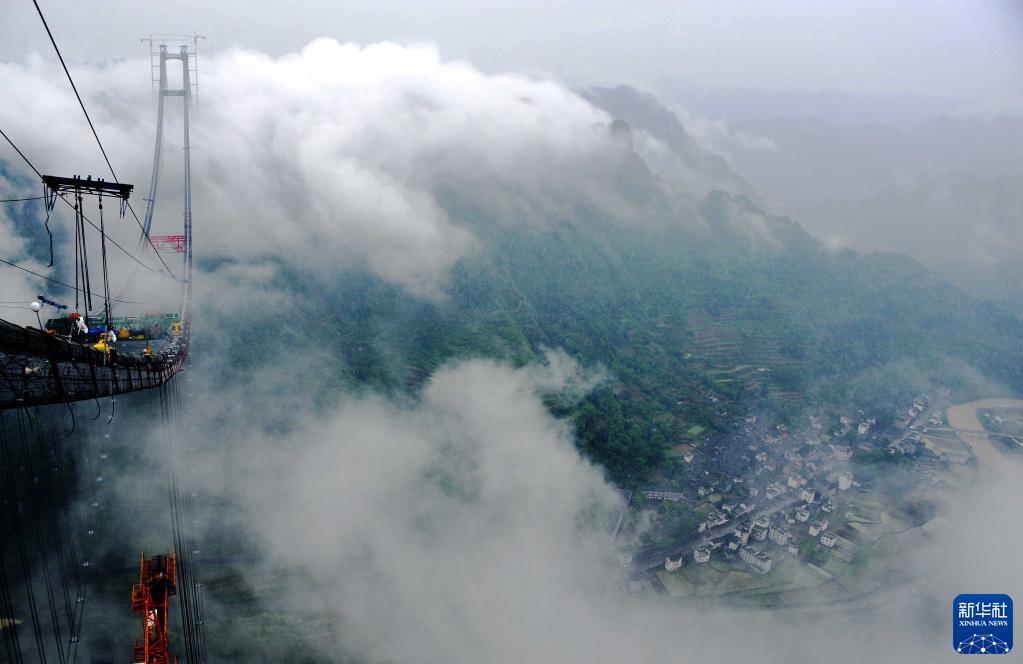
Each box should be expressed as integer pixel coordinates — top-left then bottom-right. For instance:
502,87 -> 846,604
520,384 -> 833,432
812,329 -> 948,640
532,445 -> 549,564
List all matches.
6,0 -> 1023,113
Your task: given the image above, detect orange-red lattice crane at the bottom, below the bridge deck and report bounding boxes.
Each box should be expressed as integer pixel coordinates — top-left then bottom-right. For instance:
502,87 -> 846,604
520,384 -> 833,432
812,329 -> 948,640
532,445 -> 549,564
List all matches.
131,552 -> 178,664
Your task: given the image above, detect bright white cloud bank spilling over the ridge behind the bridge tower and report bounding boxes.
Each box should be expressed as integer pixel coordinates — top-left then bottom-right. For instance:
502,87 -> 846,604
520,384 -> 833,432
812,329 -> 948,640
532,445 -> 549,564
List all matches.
0,40 -> 646,298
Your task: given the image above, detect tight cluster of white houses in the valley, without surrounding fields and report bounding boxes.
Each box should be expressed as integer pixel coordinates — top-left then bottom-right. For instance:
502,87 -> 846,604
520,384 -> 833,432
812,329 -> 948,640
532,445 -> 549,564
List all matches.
641,395 -> 930,574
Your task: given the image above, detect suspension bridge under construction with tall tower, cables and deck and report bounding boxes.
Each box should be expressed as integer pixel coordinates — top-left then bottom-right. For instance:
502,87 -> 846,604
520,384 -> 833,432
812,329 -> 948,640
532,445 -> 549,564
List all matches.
0,7 -> 207,664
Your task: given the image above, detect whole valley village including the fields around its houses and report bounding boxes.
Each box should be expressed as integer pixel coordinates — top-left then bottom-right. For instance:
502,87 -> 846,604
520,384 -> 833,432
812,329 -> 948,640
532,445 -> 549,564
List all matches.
620,394 -> 974,606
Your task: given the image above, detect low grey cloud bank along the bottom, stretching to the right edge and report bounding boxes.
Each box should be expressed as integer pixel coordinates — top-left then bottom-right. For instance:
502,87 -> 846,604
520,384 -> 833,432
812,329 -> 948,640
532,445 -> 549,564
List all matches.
121,343 -> 1021,664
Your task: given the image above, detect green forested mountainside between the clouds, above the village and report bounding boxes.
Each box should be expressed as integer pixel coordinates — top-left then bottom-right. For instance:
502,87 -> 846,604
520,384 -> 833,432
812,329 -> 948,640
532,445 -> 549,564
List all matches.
196,184 -> 1023,486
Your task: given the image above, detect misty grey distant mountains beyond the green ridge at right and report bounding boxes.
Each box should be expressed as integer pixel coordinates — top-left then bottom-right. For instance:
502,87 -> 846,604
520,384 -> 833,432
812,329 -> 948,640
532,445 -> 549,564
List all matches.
707,106 -> 1023,313
